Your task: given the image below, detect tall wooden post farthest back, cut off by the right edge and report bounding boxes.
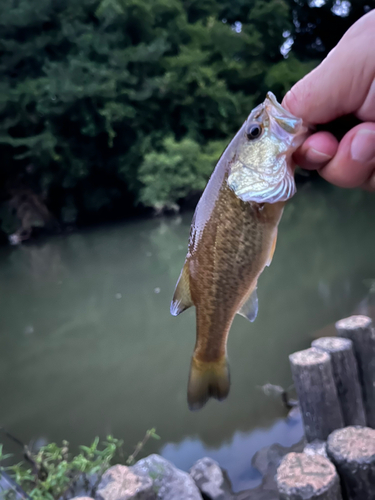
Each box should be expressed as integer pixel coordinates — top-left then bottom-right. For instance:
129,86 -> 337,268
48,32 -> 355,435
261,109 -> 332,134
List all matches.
336,316 -> 375,428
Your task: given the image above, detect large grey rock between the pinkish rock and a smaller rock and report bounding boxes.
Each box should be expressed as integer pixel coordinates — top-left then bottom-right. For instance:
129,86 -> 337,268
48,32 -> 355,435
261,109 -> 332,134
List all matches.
130,454 -> 202,500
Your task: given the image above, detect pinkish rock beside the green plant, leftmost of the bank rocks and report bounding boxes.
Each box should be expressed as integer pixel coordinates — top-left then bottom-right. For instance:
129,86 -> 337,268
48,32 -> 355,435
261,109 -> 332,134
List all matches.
95,465 -> 156,500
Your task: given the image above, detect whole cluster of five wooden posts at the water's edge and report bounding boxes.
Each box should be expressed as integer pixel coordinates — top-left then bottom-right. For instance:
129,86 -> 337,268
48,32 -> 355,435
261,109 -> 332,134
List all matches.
277,316 -> 375,500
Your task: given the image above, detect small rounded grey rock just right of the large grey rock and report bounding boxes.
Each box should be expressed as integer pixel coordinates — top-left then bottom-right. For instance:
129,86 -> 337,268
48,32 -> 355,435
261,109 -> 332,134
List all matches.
190,457 -> 233,500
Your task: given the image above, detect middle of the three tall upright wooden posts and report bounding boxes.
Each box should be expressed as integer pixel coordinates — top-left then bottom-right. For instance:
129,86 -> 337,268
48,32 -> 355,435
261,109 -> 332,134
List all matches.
311,337 -> 366,426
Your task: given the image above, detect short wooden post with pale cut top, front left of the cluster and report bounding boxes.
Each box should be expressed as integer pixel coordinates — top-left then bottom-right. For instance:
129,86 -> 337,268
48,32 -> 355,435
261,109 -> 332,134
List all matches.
276,453 -> 342,500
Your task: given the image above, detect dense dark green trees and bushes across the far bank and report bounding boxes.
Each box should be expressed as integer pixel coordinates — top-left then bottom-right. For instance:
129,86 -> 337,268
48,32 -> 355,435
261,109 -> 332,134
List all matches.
0,0 -> 375,232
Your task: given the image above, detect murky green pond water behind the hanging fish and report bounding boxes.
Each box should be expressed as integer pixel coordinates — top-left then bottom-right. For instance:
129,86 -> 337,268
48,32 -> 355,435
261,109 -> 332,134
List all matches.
0,185 -> 375,489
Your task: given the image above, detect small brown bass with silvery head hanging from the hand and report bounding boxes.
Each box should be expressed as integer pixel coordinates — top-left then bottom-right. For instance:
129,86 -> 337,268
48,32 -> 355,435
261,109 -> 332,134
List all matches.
170,92 -> 307,410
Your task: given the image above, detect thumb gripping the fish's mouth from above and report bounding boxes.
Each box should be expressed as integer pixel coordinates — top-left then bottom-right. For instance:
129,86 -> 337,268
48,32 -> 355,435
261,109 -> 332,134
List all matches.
283,11 -> 375,124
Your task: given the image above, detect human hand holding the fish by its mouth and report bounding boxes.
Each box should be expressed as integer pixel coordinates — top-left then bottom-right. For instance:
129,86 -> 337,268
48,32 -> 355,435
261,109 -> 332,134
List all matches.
282,10 -> 375,191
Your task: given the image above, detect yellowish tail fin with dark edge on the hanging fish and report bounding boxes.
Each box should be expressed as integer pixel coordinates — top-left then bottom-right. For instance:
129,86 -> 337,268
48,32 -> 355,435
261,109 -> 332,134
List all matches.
188,356 -> 230,411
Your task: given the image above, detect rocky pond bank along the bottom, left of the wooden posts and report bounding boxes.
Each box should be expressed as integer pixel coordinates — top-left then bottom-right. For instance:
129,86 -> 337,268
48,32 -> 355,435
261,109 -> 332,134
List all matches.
66,442 -> 304,500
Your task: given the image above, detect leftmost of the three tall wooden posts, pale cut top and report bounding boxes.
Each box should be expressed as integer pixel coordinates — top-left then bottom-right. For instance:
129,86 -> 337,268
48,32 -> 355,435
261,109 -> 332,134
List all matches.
289,347 -> 344,441
